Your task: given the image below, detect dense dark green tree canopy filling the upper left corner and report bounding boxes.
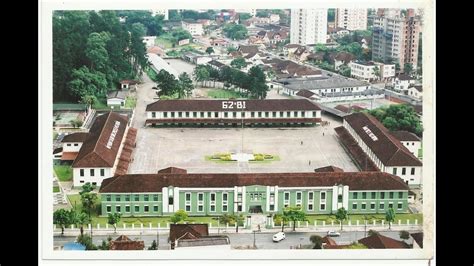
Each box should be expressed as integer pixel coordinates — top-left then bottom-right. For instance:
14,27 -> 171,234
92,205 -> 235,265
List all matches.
53,11 -> 150,102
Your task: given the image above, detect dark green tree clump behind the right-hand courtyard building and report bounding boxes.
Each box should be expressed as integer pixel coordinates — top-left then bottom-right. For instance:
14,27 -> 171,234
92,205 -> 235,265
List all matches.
369,104 -> 423,136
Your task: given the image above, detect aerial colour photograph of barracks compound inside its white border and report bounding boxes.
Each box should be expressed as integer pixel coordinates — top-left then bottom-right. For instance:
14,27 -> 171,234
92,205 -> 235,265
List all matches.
51,8 -> 431,251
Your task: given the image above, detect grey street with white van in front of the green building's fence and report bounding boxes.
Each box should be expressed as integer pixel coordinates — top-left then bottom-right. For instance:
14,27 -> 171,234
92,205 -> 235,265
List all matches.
54,229 -> 420,249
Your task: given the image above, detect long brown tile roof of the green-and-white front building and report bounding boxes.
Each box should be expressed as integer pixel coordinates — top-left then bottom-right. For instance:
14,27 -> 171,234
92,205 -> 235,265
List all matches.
100,167 -> 408,193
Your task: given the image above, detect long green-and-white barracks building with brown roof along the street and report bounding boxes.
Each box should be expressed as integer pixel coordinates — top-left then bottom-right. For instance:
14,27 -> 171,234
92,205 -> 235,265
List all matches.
100,167 -> 408,216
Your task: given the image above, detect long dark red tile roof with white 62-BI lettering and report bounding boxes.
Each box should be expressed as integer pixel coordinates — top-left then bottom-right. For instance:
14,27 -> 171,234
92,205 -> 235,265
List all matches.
146,99 -> 321,112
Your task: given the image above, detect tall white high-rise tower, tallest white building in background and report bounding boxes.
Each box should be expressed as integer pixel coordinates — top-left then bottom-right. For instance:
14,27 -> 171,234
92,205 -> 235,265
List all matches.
290,8 -> 328,45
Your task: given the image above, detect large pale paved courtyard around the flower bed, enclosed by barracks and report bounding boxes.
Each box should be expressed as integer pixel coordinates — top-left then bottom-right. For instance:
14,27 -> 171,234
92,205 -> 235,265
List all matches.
128,117 -> 358,174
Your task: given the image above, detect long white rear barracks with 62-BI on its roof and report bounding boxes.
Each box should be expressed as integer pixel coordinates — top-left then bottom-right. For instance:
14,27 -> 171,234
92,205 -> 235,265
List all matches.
145,99 -> 321,126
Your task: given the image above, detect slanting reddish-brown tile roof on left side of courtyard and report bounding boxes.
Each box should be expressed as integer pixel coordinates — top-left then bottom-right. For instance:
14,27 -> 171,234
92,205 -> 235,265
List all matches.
72,112 -> 128,167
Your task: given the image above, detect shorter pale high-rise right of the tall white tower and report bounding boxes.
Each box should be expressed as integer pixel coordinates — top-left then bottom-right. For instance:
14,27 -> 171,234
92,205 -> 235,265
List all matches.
335,8 -> 367,31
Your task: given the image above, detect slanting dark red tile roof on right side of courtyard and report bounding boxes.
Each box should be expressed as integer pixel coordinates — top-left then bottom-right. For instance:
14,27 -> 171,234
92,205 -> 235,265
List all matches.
344,113 -> 422,166
